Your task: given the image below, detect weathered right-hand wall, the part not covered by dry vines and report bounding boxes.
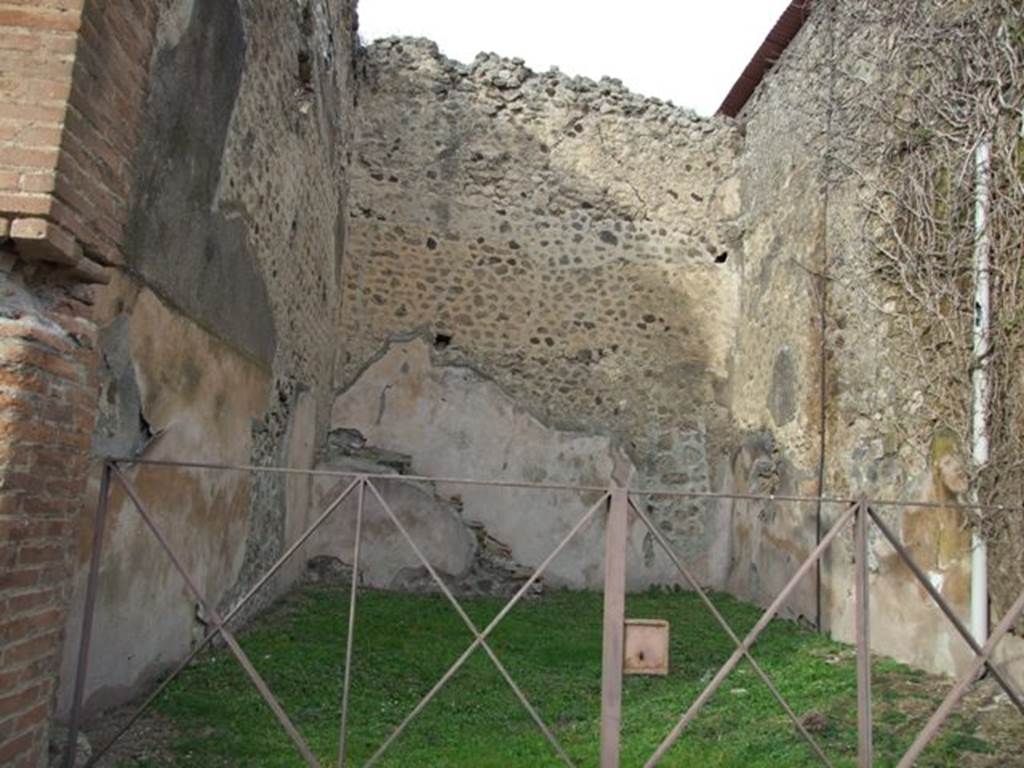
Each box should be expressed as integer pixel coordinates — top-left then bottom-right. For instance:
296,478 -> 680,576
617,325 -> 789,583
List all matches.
730,3 -> 1022,675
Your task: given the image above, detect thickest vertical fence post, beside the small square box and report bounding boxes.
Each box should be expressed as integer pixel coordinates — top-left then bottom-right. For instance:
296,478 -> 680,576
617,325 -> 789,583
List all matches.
601,485 -> 629,768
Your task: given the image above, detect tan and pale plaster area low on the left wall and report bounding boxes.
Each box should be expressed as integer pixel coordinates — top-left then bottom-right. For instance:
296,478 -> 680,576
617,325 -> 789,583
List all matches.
61,290 -> 269,710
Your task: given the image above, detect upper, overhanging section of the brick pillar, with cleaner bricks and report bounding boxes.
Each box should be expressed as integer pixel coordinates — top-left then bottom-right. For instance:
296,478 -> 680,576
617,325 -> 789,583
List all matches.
0,0 -> 157,270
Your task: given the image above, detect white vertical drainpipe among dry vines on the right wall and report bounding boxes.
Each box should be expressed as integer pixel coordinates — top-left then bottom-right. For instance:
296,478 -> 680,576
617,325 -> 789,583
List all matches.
971,138 -> 991,645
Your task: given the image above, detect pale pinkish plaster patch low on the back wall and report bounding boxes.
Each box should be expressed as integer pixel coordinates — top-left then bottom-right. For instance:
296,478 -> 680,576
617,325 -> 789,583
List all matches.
322,339 -> 728,589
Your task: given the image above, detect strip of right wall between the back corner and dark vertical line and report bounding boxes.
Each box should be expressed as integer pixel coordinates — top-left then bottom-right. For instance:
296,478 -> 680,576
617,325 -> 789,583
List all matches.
729,0 -> 824,634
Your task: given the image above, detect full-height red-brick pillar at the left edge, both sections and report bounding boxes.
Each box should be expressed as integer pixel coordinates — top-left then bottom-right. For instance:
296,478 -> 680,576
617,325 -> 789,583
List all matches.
0,0 -> 157,768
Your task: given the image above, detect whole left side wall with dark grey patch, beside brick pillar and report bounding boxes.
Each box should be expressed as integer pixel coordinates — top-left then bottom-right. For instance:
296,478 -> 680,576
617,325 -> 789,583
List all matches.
61,0 -> 355,710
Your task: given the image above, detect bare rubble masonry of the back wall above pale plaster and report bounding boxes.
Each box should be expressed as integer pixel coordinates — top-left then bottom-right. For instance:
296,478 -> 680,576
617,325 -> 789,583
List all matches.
333,39 -> 739,584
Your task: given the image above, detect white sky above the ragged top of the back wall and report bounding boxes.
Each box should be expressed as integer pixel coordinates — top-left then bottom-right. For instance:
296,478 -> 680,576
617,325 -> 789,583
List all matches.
359,0 -> 788,115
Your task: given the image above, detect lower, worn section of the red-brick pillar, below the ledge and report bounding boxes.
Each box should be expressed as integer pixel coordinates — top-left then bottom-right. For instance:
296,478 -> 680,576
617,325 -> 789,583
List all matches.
0,249 -> 97,768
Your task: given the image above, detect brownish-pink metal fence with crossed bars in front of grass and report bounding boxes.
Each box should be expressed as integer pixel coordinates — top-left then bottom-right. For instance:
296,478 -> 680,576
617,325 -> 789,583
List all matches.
65,459 -> 1024,768
